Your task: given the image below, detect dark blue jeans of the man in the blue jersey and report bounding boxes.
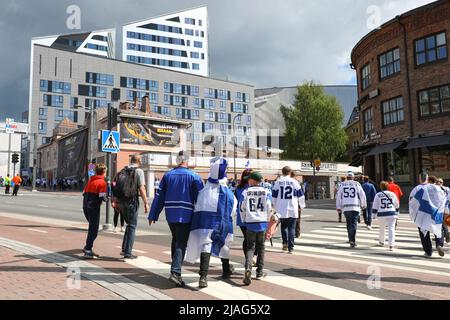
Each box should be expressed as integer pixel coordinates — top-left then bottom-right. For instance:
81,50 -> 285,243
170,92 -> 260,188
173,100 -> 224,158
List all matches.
169,223 -> 191,275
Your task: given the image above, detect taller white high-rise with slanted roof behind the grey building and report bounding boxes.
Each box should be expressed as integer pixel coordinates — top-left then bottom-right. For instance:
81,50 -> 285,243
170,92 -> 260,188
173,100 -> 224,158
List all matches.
122,6 -> 209,77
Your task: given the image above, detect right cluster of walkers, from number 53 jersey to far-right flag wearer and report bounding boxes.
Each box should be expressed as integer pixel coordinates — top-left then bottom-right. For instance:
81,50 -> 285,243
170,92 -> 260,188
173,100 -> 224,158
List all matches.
336,172 -> 450,258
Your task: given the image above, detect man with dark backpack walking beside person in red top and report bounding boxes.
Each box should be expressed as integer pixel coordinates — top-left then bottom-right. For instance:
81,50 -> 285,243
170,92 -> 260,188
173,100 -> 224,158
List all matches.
112,155 -> 149,259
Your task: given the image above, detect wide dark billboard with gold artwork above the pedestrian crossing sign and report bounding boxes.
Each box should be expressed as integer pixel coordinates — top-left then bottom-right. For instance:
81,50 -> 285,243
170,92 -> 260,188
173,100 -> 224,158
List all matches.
120,118 -> 180,147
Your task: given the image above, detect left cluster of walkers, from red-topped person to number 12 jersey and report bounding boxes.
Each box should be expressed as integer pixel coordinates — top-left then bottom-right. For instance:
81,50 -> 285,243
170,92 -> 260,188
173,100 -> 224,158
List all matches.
83,151 -> 305,288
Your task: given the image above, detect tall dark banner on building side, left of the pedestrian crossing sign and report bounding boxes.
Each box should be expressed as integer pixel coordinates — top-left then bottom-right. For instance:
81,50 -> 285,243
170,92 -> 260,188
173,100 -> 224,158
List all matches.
58,130 -> 88,180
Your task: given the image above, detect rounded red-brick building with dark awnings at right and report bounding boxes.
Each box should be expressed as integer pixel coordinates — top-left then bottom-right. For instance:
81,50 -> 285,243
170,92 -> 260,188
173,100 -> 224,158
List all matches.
351,0 -> 450,189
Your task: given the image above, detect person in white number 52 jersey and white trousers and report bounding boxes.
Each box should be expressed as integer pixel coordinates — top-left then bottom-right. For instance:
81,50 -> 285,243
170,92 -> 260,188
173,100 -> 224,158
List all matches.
367,181 -> 400,251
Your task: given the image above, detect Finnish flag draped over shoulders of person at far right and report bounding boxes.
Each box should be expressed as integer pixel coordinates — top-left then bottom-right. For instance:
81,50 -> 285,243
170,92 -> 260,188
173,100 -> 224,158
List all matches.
409,184 -> 446,238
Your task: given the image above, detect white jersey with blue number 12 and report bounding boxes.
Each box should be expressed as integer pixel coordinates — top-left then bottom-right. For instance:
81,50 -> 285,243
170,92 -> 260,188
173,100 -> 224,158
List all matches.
272,176 -> 306,219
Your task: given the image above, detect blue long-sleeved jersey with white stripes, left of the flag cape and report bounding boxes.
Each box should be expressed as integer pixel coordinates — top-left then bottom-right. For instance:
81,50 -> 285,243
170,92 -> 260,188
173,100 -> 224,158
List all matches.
148,167 -> 203,223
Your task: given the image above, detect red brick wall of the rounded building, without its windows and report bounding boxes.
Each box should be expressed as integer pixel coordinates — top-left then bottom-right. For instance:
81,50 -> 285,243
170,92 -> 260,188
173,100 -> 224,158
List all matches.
352,1 -> 450,143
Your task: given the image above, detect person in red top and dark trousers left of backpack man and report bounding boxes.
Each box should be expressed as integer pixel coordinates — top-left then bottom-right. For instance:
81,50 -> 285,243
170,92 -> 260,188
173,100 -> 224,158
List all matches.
83,163 -> 106,259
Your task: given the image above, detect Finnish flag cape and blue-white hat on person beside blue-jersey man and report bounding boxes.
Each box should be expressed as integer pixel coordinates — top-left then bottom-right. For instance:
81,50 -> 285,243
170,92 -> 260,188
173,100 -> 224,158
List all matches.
185,158 -> 237,263
